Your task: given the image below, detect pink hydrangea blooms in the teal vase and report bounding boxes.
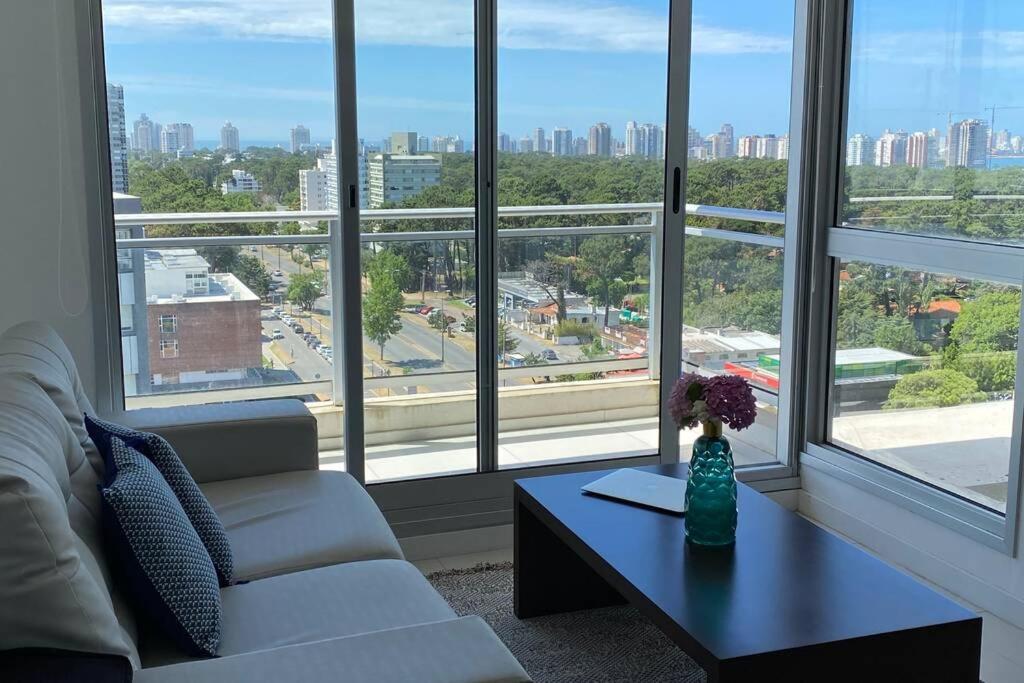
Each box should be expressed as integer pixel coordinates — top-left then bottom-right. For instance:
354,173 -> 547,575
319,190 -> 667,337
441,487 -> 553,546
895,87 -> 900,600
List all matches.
669,373 -> 757,431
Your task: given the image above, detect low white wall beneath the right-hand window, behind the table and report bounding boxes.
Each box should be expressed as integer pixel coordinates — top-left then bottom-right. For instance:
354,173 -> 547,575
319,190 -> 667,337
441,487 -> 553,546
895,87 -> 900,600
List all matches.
799,466 -> 1024,628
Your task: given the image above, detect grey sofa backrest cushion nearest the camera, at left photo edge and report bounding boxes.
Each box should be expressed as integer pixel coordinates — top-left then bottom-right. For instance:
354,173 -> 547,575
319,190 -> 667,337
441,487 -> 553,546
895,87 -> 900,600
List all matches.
0,370 -> 138,667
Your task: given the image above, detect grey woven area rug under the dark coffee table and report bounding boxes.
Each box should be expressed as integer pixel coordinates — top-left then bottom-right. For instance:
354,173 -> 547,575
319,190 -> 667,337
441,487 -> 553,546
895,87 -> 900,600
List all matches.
427,562 -> 707,683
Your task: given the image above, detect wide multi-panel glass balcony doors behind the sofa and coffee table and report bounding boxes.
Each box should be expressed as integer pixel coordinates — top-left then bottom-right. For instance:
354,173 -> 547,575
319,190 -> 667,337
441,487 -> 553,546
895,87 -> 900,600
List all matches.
96,0 -> 811,500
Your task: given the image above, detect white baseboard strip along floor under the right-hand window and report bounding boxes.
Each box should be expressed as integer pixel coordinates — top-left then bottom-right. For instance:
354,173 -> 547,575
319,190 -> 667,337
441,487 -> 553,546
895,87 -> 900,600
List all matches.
800,490 -> 1024,628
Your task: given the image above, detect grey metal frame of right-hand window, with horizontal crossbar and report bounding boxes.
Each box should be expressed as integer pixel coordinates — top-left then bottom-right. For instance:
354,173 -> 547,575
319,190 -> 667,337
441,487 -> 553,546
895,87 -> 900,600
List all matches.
800,0 -> 1024,556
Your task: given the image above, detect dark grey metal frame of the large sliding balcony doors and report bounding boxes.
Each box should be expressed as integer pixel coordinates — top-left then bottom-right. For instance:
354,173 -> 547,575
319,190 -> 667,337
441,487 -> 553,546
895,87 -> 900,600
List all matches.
83,0 -> 811,533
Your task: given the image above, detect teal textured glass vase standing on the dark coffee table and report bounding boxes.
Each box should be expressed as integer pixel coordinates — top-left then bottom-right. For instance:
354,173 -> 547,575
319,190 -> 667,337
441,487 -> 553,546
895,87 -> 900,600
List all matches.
683,422 -> 737,546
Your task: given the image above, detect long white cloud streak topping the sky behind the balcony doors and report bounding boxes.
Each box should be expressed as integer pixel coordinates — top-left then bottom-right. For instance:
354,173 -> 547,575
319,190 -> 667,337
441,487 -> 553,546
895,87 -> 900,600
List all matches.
103,0 -> 791,54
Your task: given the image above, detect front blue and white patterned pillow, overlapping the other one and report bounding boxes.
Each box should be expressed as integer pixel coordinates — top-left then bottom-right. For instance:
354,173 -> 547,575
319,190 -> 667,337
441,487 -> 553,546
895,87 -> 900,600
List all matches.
100,436 -> 221,656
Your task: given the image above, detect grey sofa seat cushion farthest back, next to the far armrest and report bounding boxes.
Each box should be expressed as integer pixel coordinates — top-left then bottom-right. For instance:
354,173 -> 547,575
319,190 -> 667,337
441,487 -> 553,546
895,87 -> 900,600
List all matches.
201,471 -> 402,581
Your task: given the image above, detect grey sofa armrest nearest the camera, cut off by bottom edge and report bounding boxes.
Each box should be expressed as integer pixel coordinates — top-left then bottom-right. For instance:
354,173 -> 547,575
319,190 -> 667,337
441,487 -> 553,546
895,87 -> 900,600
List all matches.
135,616 -> 530,683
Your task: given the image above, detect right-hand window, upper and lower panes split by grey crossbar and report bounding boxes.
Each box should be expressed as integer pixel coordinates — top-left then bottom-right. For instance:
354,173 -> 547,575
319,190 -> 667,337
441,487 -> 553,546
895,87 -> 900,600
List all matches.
804,0 -> 1024,550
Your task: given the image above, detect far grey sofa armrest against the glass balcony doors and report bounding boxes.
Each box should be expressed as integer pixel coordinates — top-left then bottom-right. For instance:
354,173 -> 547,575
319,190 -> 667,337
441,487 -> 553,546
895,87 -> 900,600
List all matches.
120,398 -> 318,483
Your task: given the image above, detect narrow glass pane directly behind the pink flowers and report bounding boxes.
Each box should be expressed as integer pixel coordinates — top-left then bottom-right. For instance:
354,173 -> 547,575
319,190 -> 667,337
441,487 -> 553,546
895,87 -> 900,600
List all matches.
680,0 -> 795,465
